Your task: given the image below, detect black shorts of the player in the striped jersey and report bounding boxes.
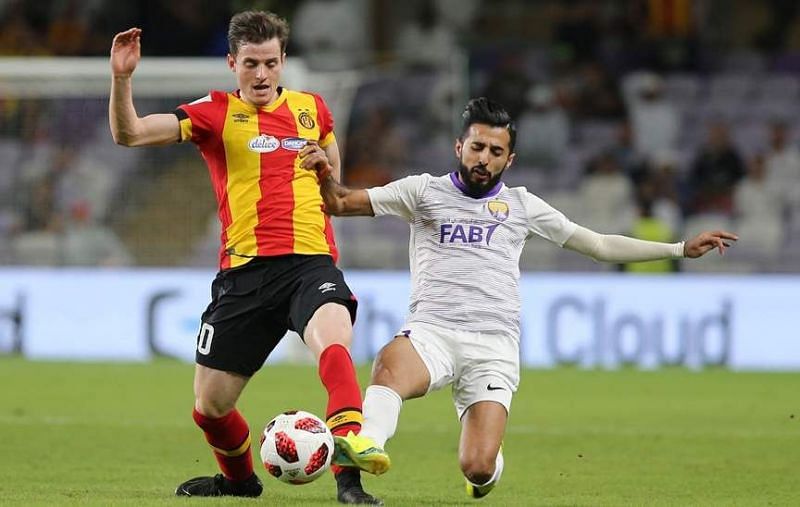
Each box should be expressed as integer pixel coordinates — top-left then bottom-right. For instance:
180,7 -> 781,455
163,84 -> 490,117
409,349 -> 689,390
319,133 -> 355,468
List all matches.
195,255 -> 357,377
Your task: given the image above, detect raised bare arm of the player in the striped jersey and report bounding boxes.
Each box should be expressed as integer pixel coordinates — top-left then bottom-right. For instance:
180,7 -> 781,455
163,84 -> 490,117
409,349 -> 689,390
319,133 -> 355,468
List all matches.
108,28 -> 180,146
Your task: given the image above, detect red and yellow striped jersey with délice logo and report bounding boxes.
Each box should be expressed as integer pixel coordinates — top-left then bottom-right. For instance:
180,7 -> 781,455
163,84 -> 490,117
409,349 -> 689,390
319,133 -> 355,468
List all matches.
175,88 -> 338,269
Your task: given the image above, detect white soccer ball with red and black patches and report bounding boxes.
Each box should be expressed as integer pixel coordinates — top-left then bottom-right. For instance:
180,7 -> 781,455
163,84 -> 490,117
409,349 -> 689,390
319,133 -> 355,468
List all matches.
261,410 -> 333,484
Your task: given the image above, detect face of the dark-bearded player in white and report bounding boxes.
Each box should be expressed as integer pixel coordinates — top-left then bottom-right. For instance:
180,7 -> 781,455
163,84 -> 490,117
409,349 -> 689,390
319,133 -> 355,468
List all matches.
456,123 -> 514,195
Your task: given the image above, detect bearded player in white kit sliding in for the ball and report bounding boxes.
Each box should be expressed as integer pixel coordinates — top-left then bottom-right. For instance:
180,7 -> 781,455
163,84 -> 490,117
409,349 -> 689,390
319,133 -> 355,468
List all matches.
320,98 -> 737,498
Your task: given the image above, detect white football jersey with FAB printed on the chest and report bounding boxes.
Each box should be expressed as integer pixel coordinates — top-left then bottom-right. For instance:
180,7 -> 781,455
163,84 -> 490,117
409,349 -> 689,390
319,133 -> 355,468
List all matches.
367,173 -> 577,339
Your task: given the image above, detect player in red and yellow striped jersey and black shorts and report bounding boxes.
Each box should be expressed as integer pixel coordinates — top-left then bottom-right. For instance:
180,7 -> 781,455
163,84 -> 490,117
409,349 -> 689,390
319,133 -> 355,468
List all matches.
109,11 -> 389,504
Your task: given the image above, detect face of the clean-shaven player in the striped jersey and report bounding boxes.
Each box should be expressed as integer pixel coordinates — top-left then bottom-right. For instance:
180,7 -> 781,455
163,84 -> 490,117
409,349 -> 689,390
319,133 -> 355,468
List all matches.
228,38 -> 286,106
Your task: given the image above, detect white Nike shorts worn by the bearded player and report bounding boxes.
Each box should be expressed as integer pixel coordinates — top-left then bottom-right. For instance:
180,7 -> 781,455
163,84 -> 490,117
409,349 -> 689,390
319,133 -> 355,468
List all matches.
400,322 -> 519,419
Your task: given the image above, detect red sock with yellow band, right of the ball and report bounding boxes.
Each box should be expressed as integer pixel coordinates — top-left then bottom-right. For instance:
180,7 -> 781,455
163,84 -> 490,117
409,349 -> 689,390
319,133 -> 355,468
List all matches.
319,343 -> 363,435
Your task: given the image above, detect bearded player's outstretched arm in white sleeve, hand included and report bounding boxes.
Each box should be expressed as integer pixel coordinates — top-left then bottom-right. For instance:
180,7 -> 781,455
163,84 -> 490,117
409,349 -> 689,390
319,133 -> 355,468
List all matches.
564,226 -> 738,263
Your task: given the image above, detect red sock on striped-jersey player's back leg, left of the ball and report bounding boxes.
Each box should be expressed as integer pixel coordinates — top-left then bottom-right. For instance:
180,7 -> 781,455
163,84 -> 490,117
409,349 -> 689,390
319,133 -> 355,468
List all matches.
192,409 -> 253,482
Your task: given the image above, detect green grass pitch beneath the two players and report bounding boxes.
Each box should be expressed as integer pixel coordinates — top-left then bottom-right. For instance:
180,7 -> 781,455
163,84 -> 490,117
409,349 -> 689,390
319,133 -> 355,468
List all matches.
0,357 -> 800,506
